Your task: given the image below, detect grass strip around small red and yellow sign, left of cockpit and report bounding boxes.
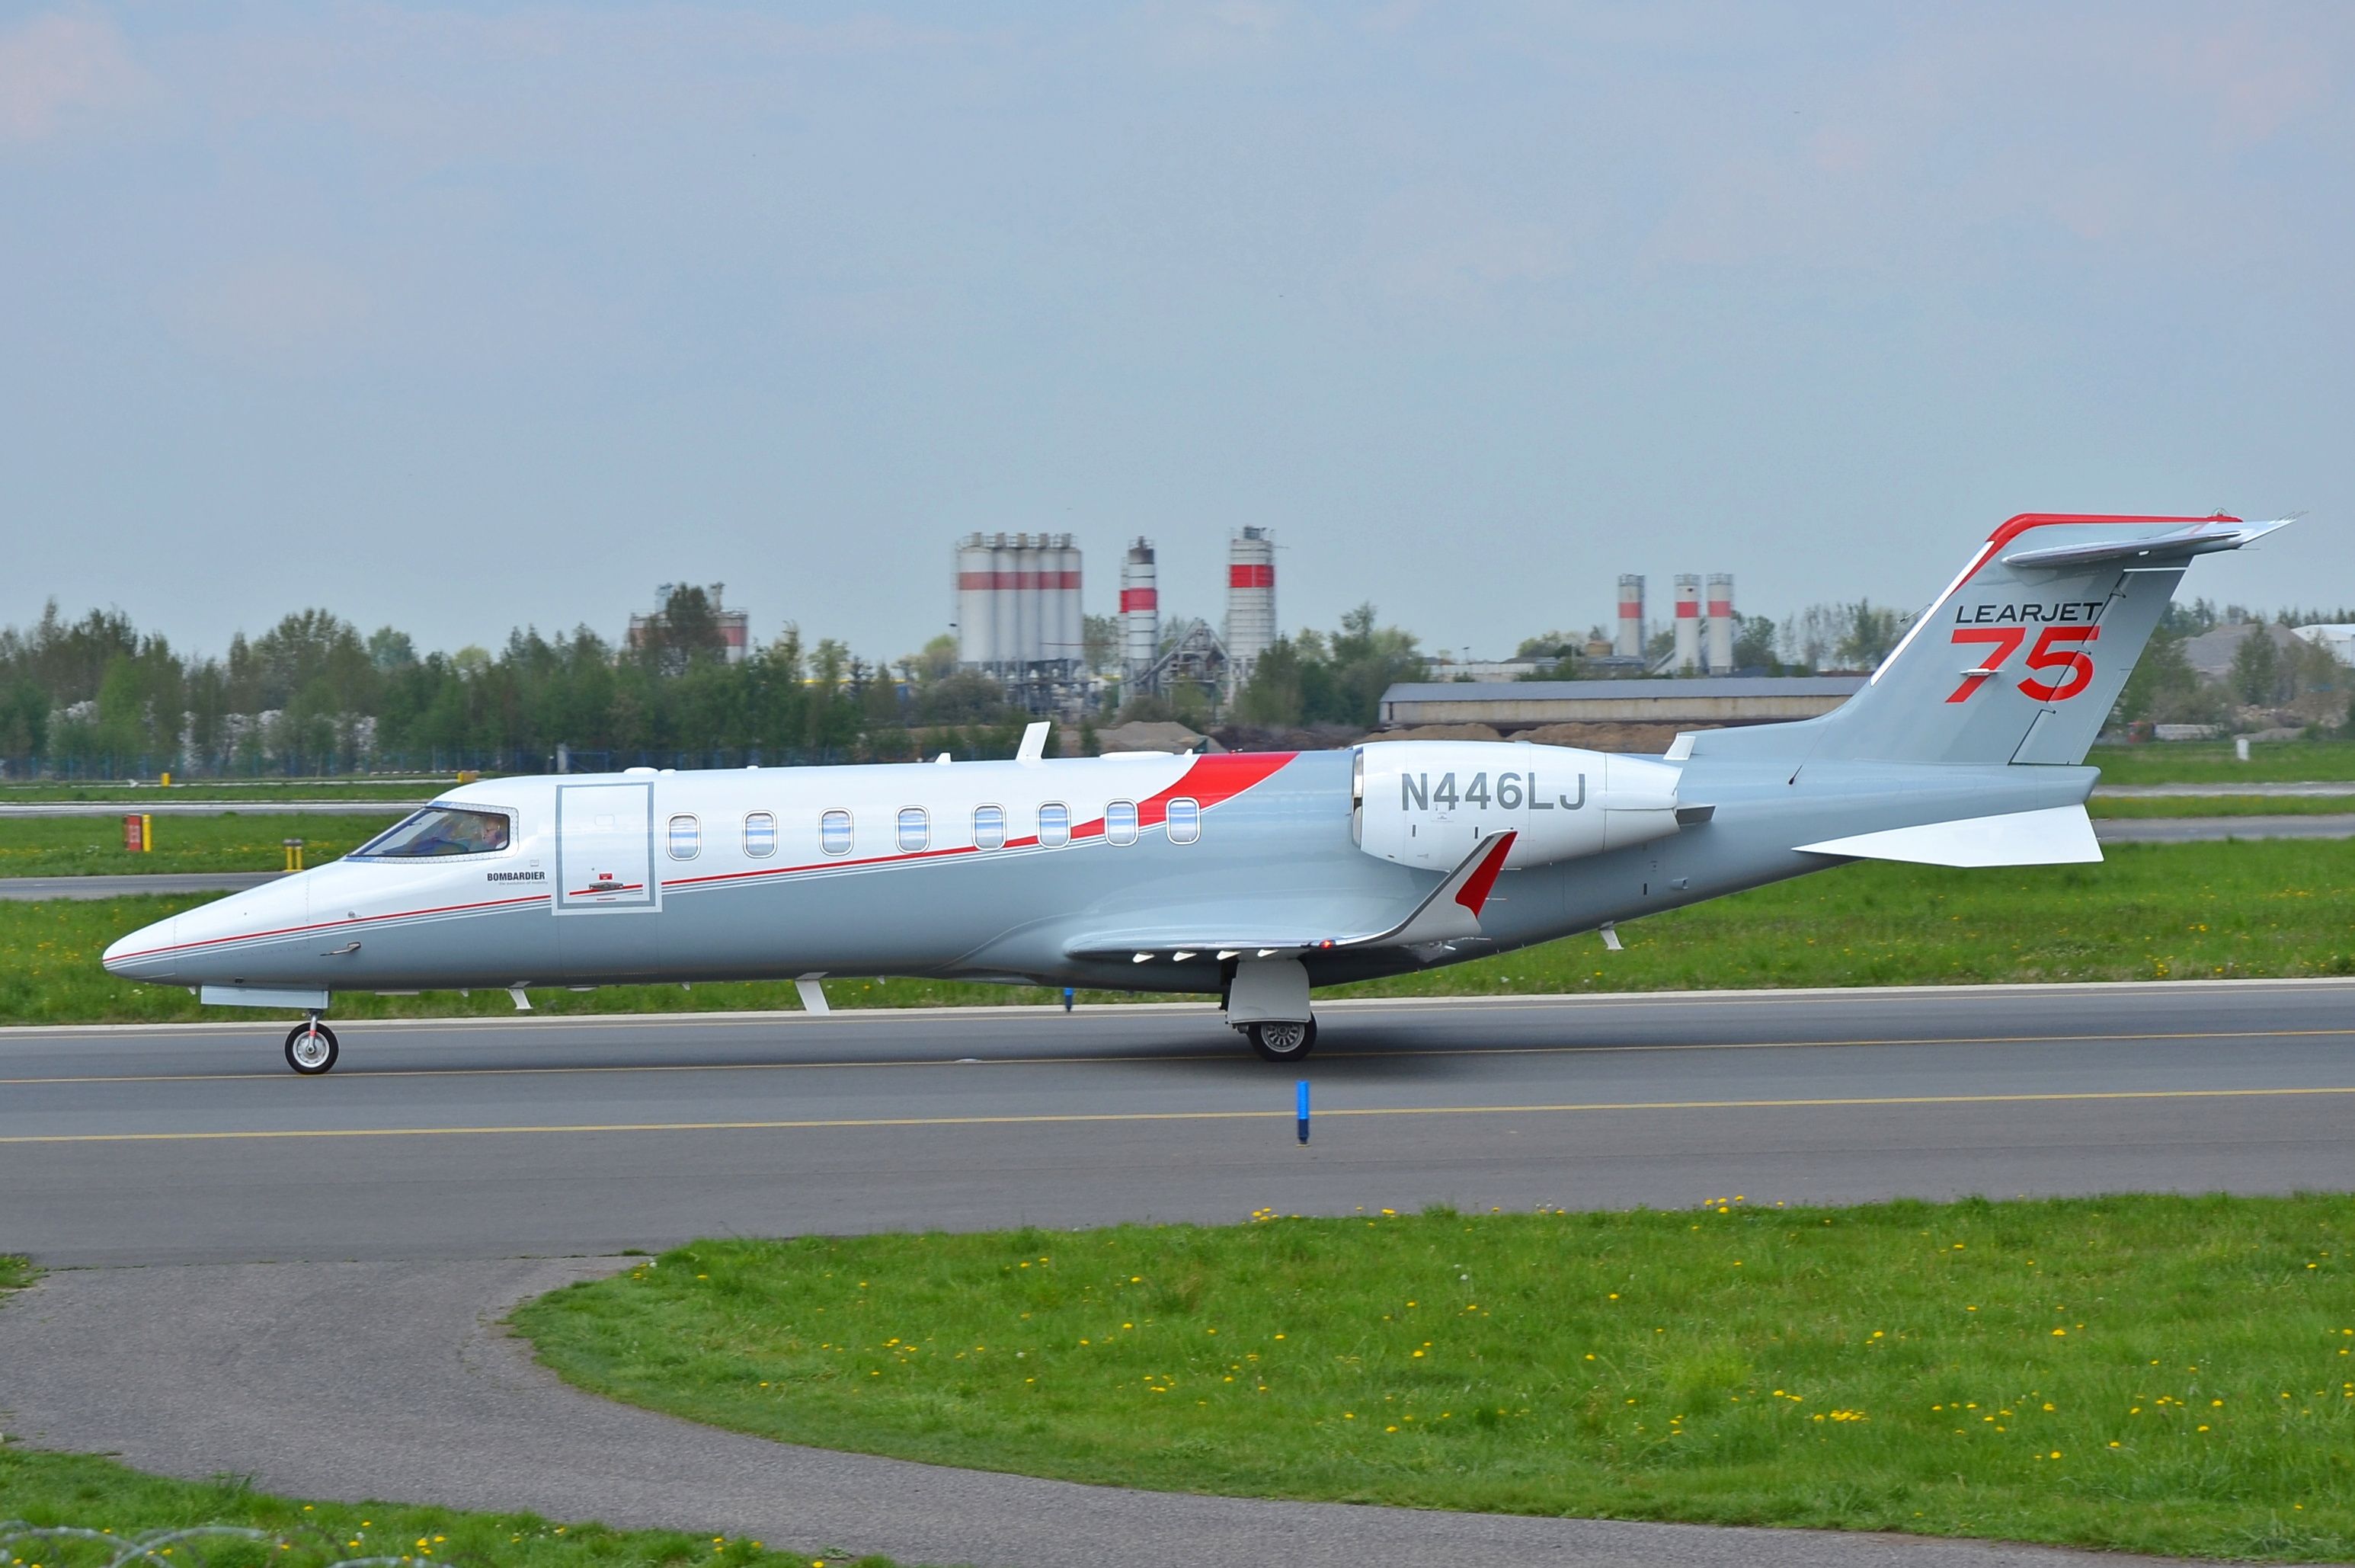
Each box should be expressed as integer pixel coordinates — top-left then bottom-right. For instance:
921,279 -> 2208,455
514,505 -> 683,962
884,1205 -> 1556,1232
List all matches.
0,810 -> 400,876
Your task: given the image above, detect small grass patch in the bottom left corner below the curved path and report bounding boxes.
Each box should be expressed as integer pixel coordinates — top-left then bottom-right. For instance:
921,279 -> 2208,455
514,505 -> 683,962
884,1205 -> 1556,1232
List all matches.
0,1443 -> 888,1568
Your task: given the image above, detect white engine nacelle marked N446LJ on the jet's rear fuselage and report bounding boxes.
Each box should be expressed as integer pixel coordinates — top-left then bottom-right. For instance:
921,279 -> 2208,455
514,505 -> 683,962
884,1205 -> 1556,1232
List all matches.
1349,741 -> 1681,871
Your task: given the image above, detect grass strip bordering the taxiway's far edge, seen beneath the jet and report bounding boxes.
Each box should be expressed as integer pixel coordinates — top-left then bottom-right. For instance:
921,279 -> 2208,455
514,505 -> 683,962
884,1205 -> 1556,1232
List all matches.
14,840 -> 2355,1024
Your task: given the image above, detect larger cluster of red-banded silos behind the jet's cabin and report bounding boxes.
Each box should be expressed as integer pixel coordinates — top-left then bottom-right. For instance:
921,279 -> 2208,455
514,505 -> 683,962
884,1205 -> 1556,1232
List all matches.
956,527 -> 1276,713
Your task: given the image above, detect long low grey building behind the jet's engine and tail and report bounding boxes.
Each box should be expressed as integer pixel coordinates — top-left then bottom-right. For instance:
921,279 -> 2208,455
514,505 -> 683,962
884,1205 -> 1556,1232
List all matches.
1382,676 -> 1865,734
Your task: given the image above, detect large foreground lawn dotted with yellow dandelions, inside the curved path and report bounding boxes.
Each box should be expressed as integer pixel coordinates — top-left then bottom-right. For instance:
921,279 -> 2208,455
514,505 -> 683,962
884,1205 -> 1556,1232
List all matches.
516,1196 -> 2355,1561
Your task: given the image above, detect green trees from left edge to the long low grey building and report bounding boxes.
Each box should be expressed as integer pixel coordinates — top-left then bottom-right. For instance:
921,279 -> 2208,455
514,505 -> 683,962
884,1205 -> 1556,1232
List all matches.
0,586 -> 1422,777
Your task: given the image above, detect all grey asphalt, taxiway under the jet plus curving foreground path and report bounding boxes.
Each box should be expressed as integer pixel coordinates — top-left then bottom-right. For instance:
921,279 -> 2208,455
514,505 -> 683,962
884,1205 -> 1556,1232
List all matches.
14,982 -> 2317,1568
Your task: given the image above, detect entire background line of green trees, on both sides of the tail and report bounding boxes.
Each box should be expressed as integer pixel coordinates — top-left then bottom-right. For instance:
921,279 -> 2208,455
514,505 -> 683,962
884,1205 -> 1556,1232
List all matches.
0,586 -> 2355,777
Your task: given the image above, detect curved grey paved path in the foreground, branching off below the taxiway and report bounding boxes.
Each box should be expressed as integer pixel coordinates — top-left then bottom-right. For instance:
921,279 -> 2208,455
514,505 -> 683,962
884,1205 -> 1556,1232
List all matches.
0,1259 -> 2155,1568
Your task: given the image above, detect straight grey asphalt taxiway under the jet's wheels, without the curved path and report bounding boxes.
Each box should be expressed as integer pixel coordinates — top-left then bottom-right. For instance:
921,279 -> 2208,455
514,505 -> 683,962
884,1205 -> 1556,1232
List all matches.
0,982 -> 2355,1264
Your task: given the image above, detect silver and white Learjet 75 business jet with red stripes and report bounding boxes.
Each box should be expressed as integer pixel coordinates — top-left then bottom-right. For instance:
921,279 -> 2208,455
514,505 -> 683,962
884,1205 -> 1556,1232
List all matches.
106,514 -> 2280,1074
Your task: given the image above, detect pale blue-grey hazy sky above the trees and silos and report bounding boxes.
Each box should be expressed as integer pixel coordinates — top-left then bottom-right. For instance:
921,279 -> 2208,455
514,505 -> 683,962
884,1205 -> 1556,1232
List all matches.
0,0 -> 2355,657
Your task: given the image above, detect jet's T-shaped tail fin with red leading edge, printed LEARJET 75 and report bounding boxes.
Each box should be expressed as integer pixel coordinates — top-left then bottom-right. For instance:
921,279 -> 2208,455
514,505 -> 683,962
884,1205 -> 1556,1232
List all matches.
1710,514 -> 2282,765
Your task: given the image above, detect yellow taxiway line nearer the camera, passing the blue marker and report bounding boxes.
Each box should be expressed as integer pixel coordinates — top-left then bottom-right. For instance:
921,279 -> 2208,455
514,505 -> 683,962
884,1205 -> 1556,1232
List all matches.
0,1086 -> 2355,1144
